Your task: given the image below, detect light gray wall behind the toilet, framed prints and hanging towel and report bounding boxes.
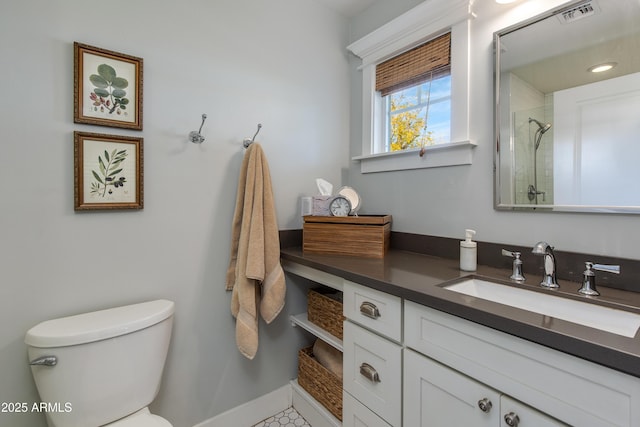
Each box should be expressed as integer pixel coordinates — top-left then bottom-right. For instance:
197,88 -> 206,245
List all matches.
0,0 -> 350,427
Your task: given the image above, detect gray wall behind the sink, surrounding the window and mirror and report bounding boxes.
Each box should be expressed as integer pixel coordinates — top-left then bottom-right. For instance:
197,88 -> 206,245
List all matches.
348,0 -> 640,260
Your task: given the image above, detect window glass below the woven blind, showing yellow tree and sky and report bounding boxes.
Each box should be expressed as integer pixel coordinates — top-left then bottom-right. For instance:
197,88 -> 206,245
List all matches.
384,75 -> 451,152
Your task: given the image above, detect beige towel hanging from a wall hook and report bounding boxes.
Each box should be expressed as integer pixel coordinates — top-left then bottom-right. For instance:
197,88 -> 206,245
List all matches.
226,143 -> 286,359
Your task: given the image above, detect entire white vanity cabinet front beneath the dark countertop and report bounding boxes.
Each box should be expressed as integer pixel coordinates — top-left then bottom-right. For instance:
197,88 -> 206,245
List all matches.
287,264 -> 640,427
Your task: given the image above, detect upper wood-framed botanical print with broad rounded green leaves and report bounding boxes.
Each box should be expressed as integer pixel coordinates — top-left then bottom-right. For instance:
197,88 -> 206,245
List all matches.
73,42 -> 143,130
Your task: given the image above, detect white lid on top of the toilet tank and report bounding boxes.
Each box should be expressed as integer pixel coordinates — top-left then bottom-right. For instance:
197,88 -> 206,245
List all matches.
24,300 -> 175,348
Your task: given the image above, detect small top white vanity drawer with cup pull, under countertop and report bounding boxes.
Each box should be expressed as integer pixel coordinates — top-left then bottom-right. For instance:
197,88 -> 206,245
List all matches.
343,281 -> 402,342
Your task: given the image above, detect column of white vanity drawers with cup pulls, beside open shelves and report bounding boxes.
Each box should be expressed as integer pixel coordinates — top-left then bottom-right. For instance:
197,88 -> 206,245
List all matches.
343,281 -> 402,427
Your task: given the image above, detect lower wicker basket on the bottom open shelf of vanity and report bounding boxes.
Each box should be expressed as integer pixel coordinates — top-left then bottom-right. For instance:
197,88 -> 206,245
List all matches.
298,346 -> 342,421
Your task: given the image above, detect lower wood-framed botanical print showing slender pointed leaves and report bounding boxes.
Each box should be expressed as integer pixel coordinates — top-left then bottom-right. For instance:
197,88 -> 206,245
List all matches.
73,131 -> 144,211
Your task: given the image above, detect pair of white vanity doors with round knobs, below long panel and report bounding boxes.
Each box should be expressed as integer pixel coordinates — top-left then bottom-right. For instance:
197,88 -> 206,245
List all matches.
403,350 -> 567,427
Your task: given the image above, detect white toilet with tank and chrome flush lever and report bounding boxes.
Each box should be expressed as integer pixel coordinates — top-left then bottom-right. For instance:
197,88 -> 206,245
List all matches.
25,300 -> 175,427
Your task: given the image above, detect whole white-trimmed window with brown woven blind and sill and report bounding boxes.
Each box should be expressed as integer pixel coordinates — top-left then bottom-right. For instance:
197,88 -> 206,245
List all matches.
348,0 -> 475,173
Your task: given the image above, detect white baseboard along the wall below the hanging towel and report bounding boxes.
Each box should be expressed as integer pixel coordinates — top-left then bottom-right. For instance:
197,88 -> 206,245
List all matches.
193,384 -> 293,427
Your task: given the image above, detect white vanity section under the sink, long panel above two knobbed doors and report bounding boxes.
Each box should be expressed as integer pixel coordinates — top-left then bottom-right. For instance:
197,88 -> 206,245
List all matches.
404,301 -> 640,427
